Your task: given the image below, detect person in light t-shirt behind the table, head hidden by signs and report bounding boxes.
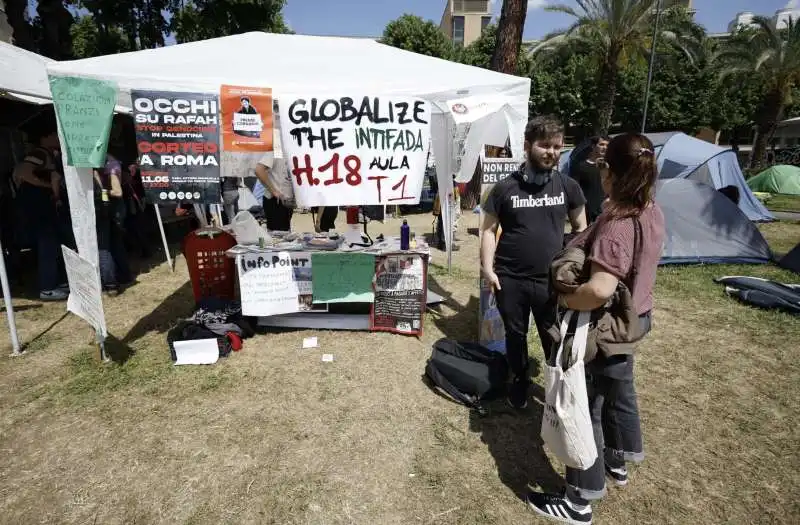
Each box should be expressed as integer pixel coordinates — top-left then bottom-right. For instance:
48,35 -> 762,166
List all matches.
255,133 -> 294,231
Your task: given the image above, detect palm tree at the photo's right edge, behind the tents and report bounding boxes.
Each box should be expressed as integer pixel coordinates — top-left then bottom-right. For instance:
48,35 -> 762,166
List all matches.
716,16 -> 800,168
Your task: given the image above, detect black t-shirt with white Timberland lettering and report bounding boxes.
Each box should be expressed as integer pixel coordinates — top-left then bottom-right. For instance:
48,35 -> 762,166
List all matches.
484,167 -> 586,278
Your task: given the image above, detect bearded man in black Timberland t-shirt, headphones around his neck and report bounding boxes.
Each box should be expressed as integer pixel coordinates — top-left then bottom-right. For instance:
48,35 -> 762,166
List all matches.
481,117 -> 586,408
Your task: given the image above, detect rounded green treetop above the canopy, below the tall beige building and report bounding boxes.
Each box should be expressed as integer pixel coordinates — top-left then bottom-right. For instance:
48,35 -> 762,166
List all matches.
380,14 -> 456,60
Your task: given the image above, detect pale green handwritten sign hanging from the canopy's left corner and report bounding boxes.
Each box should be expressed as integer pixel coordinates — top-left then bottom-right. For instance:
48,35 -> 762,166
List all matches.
50,77 -> 117,168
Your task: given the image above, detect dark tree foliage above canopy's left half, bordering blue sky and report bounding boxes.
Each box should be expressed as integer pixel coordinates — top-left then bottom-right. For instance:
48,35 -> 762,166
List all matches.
170,0 -> 290,42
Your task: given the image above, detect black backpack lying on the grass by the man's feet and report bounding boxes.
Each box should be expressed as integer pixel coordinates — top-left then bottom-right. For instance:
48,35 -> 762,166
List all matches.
425,339 -> 508,413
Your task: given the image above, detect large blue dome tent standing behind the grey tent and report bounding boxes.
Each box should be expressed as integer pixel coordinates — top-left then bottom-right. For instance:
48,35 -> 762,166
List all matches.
559,131 -> 775,221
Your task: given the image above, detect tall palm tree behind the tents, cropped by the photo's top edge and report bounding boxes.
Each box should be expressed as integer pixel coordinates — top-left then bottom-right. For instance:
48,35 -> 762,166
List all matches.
533,0 -> 692,134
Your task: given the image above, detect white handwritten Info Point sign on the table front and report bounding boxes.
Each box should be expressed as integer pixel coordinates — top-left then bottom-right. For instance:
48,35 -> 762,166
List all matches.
236,252 -> 299,316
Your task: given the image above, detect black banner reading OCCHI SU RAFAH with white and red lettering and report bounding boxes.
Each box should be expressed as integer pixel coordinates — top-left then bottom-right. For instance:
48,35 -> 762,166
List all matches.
131,90 -> 222,204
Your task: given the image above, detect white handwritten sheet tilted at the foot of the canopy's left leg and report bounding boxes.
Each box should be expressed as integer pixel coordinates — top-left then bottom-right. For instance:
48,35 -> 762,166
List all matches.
61,246 -> 108,337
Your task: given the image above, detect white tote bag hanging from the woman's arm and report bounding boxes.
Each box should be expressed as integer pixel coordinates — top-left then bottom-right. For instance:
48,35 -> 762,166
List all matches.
542,310 -> 597,470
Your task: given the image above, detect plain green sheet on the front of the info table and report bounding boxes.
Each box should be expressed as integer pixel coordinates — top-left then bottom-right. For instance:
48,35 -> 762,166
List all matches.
311,252 -> 375,303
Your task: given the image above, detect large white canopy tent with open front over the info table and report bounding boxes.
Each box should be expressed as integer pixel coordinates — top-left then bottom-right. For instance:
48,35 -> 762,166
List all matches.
42,32 -> 530,338
